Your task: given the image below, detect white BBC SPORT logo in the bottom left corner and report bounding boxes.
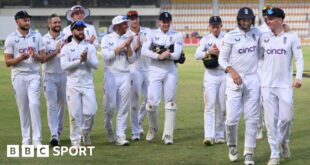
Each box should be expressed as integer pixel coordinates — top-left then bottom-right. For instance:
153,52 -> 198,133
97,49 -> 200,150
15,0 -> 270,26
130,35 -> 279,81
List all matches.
6,145 -> 95,158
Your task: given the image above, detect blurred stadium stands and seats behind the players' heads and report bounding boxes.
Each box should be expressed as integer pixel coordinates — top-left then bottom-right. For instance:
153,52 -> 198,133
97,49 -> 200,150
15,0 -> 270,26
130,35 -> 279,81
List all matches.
0,0 -> 310,45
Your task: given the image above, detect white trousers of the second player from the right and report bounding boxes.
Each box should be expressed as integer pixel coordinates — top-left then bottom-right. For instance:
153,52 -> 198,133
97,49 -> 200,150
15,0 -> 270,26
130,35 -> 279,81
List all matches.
226,74 -> 260,154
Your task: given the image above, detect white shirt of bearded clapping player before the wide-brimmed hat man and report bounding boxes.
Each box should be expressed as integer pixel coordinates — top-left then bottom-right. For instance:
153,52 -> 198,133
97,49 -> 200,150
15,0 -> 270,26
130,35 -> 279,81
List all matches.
60,39 -> 99,88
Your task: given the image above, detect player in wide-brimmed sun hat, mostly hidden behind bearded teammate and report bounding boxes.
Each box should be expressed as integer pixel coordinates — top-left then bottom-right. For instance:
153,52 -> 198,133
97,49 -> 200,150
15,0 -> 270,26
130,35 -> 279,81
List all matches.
63,5 -> 99,47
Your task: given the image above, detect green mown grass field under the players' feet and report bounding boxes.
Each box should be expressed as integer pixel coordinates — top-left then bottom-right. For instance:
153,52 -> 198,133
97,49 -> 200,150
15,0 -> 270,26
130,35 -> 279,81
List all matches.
0,47 -> 310,165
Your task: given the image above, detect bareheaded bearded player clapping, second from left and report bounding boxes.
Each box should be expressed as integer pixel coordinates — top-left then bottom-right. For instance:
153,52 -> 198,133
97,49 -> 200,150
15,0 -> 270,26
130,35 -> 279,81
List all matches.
42,14 -> 66,146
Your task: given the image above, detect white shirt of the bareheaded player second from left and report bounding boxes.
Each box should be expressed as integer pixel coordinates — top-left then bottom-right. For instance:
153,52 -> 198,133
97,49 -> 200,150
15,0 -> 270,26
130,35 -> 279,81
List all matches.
42,33 -> 65,73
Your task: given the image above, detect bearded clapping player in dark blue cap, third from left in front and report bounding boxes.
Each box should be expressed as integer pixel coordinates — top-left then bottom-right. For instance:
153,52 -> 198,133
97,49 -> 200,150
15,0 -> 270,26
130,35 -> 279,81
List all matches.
61,21 -> 99,148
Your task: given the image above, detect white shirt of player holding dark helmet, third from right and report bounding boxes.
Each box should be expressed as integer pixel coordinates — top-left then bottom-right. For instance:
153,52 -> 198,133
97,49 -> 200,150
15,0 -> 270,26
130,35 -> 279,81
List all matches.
195,32 -> 225,71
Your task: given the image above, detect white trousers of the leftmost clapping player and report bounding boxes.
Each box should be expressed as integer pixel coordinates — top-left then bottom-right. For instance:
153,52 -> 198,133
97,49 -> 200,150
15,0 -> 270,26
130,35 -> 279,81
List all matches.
12,72 -> 42,144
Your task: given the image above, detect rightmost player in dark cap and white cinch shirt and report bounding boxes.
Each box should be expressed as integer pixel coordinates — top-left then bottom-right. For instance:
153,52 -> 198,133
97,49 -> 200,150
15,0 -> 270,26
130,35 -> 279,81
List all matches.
260,7 -> 304,165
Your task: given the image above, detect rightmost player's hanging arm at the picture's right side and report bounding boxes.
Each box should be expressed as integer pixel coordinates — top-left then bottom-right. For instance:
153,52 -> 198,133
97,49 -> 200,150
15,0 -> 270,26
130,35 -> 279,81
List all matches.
292,34 -> 304,88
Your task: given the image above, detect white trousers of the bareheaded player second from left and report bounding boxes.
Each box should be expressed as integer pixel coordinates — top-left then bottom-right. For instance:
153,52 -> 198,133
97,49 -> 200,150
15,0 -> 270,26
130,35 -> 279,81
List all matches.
43,72 -> 67,139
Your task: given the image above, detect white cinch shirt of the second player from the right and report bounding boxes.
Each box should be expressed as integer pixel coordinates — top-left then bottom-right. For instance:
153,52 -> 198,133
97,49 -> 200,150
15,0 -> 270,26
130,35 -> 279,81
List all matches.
219,28 -> 261,75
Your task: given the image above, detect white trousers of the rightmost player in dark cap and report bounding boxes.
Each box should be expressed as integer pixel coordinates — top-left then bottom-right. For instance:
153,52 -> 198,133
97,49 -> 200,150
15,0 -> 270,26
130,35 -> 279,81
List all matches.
262,87 -> 294,158
